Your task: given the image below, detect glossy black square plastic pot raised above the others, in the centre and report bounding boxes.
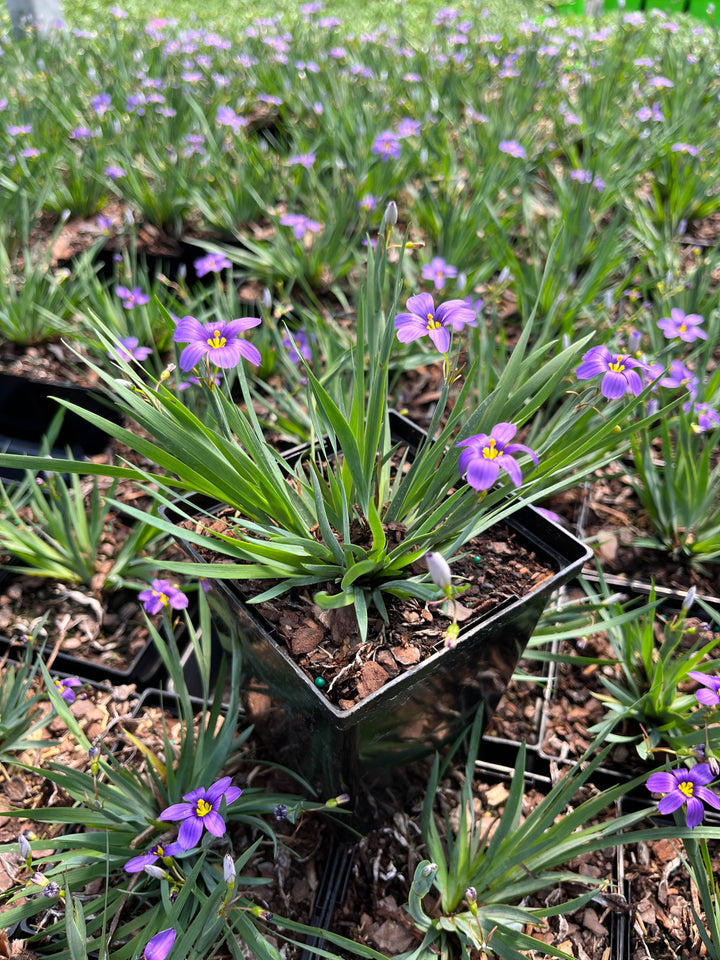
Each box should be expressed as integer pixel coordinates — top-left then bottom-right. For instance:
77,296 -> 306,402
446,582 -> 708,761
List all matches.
160,414 -> 592,796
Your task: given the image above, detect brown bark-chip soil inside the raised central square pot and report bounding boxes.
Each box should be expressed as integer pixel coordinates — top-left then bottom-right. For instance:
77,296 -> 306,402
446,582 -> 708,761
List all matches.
185,511 -> 555,710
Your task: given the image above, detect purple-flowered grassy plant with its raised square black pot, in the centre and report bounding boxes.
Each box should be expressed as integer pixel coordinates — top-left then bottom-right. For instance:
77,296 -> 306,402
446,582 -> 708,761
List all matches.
0,218 -> 664,788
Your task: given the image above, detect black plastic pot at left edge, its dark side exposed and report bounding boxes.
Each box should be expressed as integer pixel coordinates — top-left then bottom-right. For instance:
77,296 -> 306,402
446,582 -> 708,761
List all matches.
0,373 -> 120,480
